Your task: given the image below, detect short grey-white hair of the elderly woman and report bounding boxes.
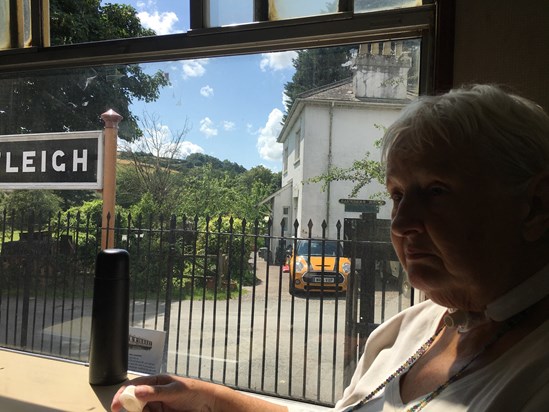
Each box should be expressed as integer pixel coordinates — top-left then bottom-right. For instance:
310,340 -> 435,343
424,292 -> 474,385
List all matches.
381,85 -> 549,186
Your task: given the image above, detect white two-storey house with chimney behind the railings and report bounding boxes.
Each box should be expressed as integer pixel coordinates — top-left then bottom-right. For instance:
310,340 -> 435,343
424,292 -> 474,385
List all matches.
268,42 -> 411,238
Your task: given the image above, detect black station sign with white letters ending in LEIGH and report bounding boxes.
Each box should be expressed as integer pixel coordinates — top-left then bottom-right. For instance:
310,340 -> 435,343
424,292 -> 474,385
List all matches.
0,131 -> 103,190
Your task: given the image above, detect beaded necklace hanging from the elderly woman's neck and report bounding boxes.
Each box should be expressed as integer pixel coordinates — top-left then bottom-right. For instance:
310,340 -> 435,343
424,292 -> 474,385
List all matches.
347,312 -> 525,412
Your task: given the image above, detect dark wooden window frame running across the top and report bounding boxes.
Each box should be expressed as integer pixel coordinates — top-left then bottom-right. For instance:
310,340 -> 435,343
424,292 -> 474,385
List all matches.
0,0 -> 455,93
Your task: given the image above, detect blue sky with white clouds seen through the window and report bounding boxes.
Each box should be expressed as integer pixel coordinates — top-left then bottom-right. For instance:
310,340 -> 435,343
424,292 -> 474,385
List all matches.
100,0 -> 336,172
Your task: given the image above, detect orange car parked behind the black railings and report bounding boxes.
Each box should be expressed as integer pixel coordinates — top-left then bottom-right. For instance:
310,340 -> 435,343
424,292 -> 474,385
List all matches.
288,239 -> 351,295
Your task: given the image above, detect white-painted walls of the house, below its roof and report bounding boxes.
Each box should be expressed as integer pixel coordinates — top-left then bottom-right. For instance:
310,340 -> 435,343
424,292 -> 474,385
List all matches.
283,98 -> 402,237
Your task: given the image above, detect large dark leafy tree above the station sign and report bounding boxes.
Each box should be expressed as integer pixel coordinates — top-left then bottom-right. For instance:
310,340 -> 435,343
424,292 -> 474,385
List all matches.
0,0 -> 169,141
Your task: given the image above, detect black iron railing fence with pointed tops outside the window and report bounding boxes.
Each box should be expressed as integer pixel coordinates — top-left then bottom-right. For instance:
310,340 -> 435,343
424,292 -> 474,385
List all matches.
0,211 -> 410,405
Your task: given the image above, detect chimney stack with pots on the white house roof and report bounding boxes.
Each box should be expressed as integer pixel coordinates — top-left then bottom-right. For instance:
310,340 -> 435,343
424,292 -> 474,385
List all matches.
353,41 -> 412,100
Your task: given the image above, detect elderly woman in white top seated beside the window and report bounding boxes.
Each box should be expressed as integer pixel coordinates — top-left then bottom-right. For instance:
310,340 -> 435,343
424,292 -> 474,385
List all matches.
112,85 -> 549,412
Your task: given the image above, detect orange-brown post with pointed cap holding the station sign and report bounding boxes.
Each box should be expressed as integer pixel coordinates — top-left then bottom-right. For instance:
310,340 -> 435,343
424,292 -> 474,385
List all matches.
101,109 -> 122,249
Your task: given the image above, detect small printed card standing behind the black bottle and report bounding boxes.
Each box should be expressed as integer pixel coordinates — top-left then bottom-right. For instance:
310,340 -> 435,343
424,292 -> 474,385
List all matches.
128,327 -> 166,374
